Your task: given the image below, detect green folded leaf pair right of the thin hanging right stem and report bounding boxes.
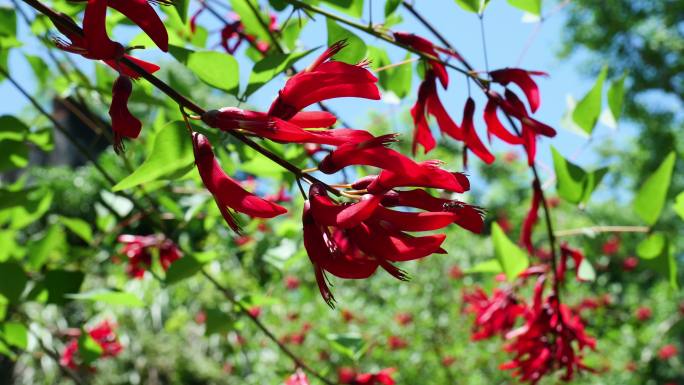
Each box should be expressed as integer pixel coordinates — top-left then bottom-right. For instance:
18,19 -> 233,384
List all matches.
551,147 -> 608,204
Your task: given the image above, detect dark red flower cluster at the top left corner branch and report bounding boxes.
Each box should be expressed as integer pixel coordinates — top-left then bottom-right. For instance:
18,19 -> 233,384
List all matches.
53,0 -> 171,151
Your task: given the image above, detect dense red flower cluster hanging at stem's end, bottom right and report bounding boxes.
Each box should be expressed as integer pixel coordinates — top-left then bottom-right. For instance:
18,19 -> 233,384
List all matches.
501,276 -> 596,384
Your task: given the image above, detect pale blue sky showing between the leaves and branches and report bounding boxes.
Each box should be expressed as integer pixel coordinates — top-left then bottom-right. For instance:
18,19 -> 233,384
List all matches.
0,0 -> 623,175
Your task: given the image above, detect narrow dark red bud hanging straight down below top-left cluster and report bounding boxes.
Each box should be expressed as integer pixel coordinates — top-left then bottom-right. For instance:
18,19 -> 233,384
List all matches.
109,75 -> 142,153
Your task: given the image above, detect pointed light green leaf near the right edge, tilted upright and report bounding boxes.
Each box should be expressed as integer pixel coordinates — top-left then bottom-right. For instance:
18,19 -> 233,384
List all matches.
633,152 -> 677,226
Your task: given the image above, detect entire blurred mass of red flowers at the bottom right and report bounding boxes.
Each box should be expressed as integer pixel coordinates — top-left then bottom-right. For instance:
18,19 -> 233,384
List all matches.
463,244 -> 596,384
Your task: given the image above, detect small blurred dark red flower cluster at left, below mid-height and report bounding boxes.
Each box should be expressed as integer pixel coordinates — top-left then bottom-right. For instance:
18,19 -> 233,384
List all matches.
117,234 -> 183,279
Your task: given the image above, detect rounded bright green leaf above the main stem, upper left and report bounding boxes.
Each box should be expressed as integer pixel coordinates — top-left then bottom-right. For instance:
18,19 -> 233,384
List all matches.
188,51 -> 240,95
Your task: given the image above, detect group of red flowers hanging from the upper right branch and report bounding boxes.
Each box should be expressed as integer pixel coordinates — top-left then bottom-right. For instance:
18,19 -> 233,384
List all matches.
394,32 -> 556,164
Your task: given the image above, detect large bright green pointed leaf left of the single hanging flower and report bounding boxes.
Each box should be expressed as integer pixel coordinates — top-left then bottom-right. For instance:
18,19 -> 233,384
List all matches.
112,121 -> 194,191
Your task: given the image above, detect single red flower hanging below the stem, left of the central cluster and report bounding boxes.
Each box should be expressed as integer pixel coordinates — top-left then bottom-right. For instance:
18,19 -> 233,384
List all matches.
192,133 -> 287,232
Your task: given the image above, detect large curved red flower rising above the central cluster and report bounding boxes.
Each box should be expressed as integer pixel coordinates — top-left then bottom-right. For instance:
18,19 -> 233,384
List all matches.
268,41 -> 380,120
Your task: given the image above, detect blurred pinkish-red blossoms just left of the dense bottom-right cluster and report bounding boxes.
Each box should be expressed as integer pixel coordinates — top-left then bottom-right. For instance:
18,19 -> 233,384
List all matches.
463,287 -> 527,341
